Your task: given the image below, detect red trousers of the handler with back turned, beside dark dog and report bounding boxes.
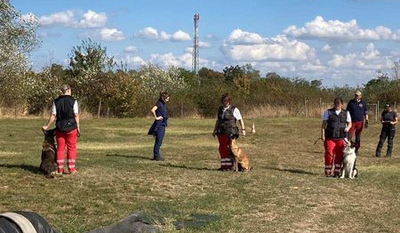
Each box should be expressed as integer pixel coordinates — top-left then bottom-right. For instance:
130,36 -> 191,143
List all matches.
56,129 -> 78,173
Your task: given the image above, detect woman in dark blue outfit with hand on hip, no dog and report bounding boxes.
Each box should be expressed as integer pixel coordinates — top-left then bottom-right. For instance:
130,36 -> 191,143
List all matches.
148,91 -> 170,161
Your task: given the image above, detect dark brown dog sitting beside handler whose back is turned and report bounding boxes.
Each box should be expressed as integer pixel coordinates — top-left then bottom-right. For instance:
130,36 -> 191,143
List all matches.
40,129 -> 57,178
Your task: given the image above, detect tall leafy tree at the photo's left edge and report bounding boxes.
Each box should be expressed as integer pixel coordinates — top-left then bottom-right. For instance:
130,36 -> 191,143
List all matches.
0,0 -> 39,116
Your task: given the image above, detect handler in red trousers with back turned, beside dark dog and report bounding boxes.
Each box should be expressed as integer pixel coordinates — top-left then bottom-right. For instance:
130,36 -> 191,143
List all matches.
42,85 -> 80,175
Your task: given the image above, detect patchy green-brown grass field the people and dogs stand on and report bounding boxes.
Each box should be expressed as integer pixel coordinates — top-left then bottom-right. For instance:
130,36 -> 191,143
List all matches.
0,118 -> 400,233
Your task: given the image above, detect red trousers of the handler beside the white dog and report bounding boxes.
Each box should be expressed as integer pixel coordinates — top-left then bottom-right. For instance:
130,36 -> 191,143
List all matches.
324,139 -> 344,176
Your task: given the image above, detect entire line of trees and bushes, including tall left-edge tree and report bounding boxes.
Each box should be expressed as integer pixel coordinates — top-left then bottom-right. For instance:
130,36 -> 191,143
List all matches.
0,0 -> 400,117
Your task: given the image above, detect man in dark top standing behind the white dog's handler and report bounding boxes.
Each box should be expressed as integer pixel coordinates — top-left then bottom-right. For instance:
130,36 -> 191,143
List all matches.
346,91 -> 368,155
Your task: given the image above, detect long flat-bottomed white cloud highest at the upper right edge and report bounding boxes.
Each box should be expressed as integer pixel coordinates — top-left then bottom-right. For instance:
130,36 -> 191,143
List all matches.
284,16 -> 400,41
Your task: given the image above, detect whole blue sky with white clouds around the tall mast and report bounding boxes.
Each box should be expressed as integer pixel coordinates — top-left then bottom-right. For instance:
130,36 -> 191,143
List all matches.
11,0 -> 400,86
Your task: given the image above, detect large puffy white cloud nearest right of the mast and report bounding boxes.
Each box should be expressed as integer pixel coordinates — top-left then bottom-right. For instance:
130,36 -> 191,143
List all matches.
221,29 -> 315,62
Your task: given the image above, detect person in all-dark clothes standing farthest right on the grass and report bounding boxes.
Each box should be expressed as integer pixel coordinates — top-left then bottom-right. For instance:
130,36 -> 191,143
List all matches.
375,104 -> 399,157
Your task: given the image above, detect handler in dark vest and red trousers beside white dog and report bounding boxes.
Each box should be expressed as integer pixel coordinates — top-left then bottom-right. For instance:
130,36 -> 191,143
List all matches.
321,97 -> 351,177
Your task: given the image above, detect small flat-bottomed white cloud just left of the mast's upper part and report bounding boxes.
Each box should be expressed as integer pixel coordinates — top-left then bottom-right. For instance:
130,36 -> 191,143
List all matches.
135,27 -> 190,41
